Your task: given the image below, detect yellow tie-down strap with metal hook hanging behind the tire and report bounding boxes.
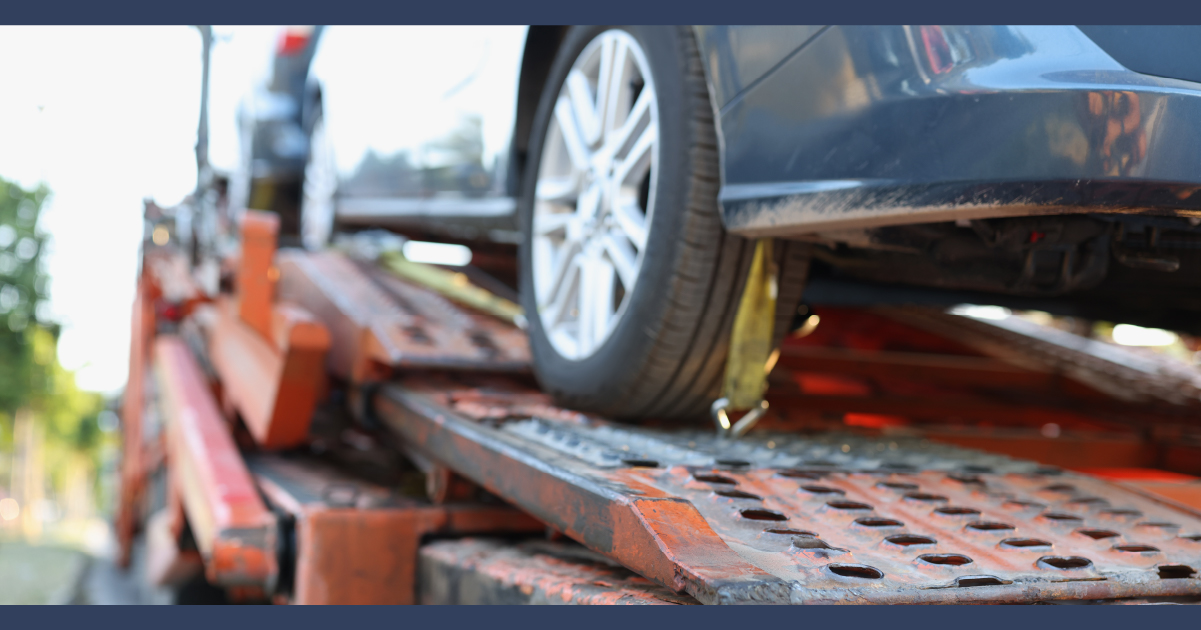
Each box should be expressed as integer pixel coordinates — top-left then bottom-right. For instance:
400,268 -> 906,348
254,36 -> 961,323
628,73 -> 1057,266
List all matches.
722,239 -> 778,410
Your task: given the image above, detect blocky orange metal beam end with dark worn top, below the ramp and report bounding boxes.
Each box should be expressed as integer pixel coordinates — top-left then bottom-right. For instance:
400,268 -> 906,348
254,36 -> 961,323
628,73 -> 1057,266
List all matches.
250,455 -> 545,604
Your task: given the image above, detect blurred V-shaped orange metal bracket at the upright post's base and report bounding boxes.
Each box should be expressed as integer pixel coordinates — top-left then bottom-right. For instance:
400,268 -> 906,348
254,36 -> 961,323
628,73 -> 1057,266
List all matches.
208,300 -> 330,449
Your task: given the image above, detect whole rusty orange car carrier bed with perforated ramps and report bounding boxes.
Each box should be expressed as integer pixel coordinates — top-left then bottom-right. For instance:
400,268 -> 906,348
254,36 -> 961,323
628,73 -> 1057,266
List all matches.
118,214 -> 1201,604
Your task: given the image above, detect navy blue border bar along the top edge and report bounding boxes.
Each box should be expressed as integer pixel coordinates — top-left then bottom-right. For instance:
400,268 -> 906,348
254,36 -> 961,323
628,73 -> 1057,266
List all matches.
11,0 -> 1201,24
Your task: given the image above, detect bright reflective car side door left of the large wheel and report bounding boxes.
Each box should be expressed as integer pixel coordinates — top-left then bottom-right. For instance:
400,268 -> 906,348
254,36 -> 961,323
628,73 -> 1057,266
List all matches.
310,26 -> 526,235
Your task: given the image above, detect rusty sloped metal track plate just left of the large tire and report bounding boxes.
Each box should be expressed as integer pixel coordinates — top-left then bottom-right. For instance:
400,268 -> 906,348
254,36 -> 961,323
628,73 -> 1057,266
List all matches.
279,251 -> 530,383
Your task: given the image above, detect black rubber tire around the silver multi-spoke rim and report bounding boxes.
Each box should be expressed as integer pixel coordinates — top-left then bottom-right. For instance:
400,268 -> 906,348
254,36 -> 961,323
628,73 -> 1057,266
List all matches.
519,26 -> 807,419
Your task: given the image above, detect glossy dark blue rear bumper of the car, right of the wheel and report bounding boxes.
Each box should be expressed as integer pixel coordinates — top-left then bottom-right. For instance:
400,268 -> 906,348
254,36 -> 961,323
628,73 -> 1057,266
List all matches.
706,26 -> 1201,236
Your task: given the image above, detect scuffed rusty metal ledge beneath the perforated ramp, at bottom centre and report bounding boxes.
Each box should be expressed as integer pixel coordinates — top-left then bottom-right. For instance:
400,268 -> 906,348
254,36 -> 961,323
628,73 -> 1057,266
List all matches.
419,539 -> 699,605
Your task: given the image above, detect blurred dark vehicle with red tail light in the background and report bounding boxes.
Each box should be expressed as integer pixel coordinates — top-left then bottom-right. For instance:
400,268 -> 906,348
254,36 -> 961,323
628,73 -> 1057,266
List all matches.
235,25 -> 323,238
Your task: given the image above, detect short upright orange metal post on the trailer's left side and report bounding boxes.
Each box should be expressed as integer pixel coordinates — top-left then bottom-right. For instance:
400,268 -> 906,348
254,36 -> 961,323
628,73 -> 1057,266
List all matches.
238,210 -> 280,338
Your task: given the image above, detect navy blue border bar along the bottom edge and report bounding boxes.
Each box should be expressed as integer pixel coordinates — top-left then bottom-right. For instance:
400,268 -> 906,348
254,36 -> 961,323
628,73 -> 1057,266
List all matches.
9,605 -> 1201,630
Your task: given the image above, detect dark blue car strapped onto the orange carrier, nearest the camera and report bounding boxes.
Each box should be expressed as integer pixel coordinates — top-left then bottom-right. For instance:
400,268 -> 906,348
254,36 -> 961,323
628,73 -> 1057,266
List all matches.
300,25 -> 1201,419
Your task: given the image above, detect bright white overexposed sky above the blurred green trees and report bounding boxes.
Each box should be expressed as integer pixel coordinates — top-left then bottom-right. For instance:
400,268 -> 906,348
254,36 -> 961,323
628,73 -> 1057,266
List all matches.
0,26 -> 279,394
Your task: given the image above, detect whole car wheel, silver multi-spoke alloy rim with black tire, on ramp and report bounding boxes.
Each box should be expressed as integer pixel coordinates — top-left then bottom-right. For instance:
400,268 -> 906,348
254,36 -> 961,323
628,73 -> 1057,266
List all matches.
519,26 -> 799,418
